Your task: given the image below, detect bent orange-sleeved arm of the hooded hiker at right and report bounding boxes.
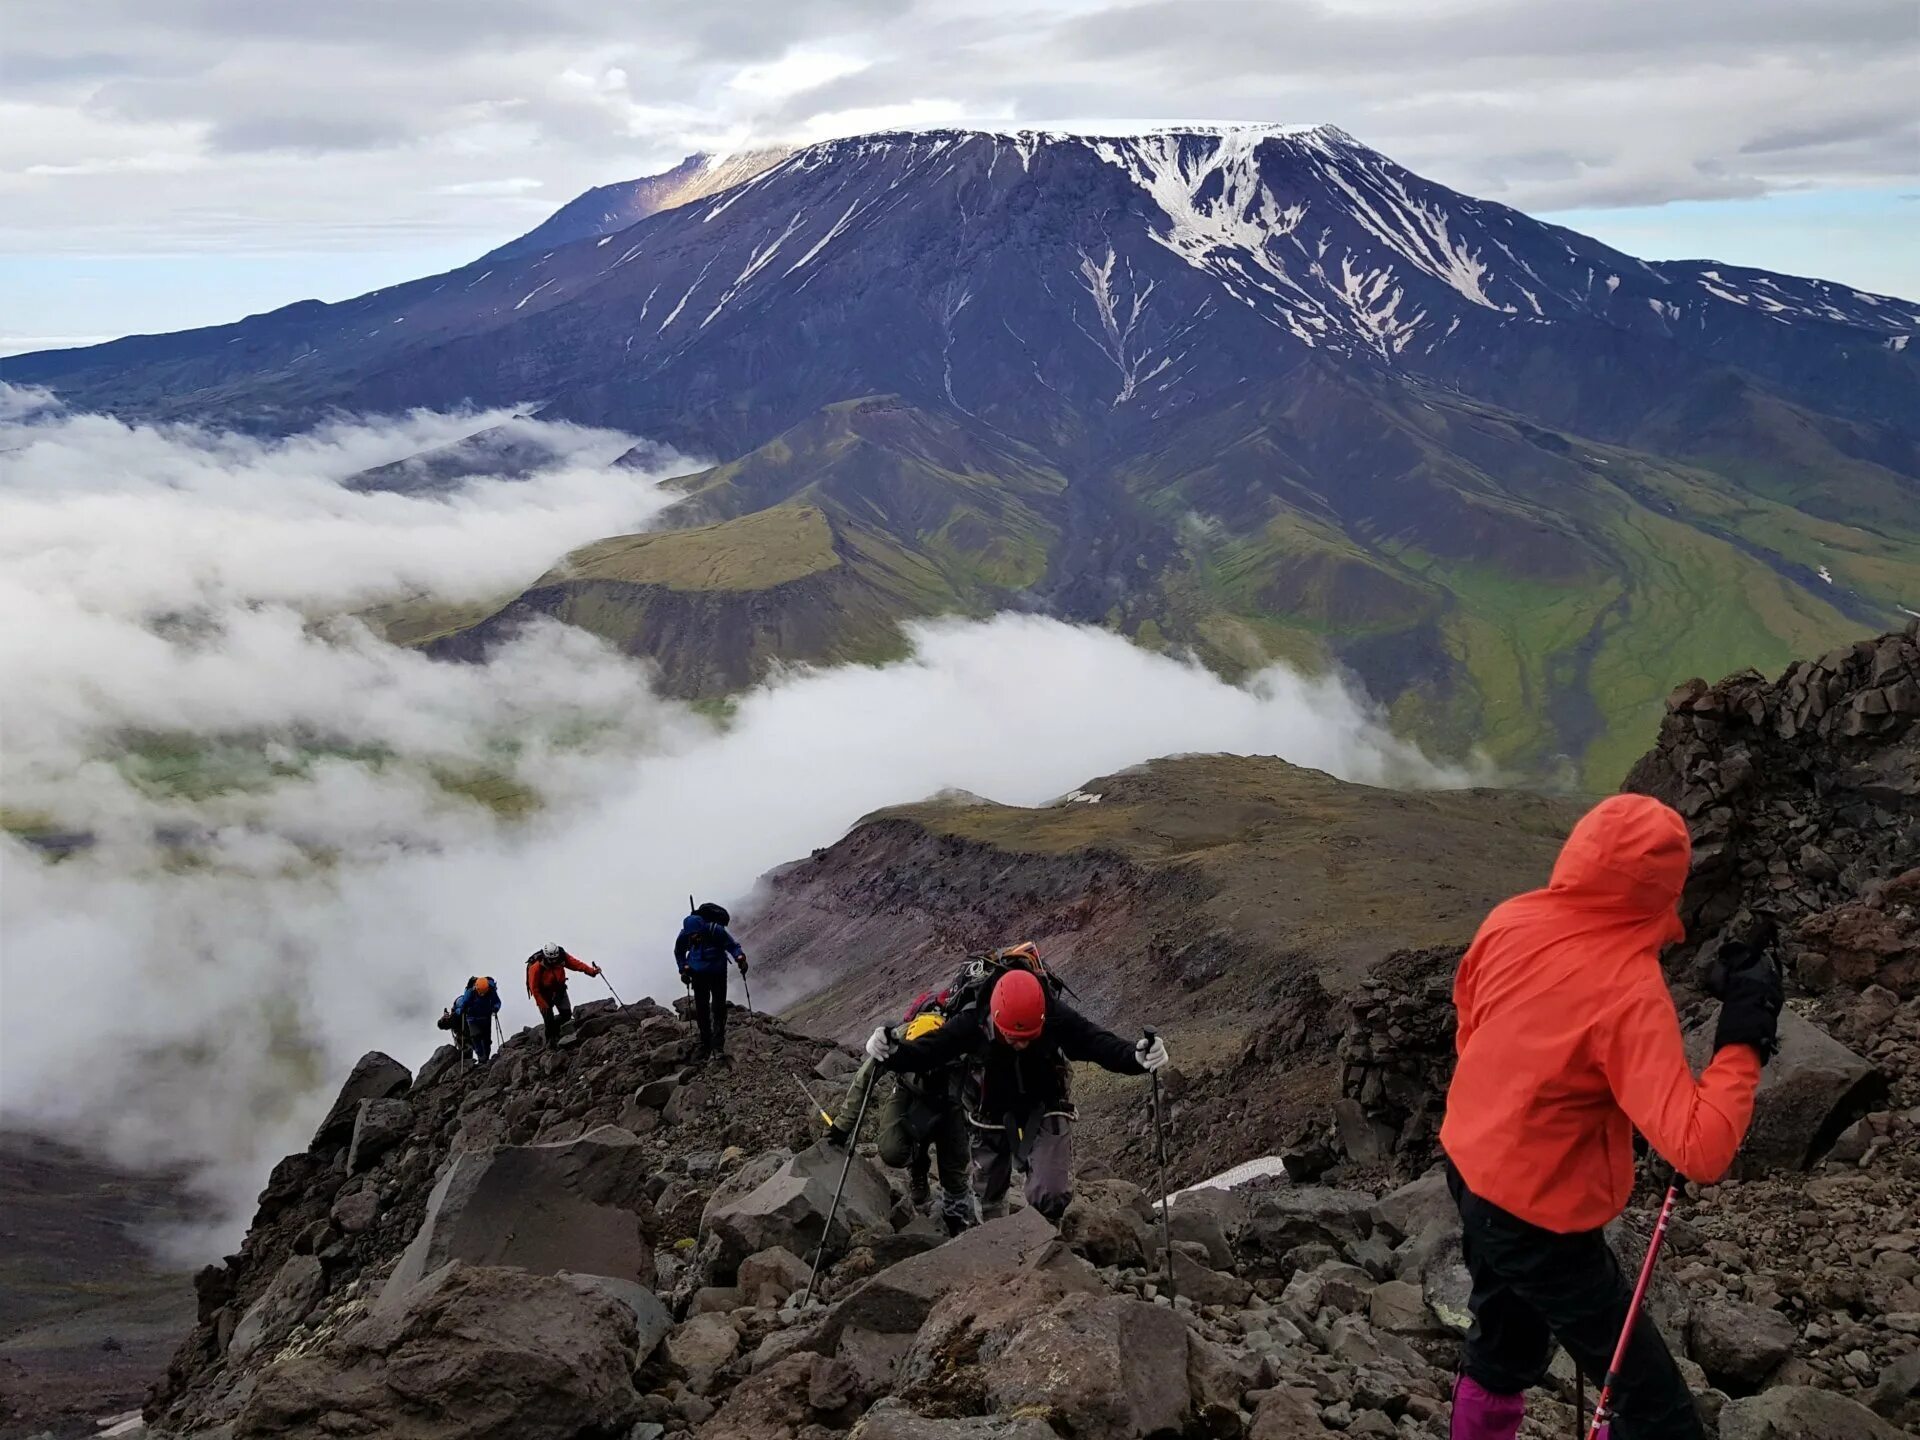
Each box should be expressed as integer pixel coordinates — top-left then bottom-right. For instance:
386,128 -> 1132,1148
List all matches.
1597,981 -> 1761,1185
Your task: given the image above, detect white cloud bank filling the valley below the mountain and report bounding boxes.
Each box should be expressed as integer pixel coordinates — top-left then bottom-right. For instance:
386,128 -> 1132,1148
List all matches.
0,392 -> 1461,1238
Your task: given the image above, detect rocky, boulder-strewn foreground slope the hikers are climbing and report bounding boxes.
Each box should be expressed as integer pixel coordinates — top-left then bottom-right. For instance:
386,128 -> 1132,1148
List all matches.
22,624 -> 1920,1440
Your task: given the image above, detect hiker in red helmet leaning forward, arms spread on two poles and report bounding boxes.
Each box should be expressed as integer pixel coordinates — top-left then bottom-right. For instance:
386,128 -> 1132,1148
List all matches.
866,945 -> 1167,1221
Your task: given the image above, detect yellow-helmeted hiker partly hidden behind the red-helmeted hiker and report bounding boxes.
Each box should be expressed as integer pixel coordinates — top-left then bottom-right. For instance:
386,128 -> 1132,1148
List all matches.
828,995 -> 973,1235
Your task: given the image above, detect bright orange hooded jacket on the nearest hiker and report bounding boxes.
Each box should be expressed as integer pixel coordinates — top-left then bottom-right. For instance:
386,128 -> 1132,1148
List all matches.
1440,795 -> 1761,1235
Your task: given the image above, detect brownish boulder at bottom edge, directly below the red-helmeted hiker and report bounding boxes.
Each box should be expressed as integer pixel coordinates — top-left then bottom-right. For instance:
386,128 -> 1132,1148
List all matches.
985,1294 -> 1192,1440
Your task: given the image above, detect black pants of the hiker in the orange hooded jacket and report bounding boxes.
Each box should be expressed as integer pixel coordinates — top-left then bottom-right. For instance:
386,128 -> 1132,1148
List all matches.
1446,1162 -> 1705,1440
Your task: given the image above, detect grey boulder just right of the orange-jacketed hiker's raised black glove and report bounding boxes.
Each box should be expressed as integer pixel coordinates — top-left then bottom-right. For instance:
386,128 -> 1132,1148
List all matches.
1688,1008 -> 1887,1179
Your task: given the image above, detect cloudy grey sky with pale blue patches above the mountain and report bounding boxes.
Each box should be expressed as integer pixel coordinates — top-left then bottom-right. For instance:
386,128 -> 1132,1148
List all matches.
0,0 -> 1920,349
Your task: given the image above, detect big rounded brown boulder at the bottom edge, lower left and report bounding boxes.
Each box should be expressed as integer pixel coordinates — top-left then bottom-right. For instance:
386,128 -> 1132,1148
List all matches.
232,1261 -> 639,1440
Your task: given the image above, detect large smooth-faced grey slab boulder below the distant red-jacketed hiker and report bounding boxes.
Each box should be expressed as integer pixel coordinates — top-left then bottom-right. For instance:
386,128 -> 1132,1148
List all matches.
376,1125 -> 655,1309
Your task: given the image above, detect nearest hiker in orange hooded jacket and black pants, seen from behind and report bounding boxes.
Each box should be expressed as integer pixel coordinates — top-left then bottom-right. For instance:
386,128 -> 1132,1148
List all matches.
1440,795 -> 1782,1440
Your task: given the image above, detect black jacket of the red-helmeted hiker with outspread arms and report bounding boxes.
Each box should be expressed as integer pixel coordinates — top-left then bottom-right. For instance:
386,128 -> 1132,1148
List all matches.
885,1000 -> 1146,1123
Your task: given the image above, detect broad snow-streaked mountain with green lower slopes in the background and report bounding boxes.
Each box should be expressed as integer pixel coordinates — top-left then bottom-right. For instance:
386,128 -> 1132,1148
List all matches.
0,127 -> 1920,785
